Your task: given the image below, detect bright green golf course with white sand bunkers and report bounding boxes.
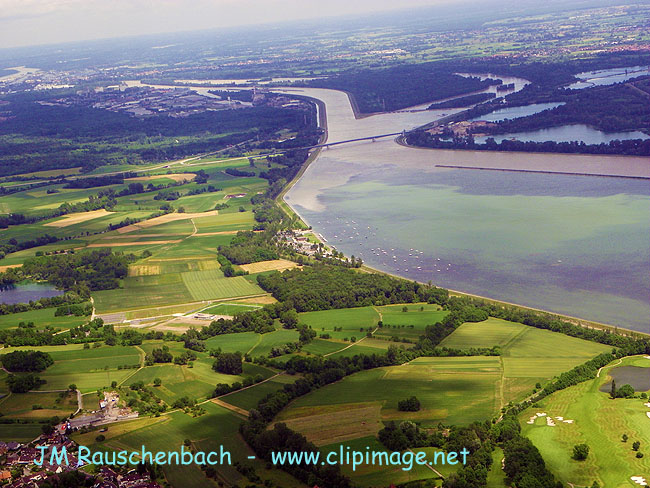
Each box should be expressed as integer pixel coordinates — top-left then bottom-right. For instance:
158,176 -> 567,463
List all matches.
519,356 -> 650,486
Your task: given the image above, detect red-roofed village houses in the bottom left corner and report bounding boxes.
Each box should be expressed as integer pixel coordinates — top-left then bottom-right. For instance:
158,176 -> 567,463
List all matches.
0,429 -> 160,488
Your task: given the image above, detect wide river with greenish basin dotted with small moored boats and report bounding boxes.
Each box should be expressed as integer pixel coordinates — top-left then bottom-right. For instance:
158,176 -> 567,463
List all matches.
274,89 -> 650,332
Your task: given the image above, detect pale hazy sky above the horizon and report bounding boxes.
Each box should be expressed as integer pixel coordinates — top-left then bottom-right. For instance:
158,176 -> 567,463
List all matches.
0,0 -> 442,48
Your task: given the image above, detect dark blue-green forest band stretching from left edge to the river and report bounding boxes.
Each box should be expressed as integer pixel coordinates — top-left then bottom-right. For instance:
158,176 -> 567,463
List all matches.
0,93 -> 311,176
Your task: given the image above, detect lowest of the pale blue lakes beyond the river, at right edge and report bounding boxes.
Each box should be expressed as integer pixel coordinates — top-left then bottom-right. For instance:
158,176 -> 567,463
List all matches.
474,124 -> 650,144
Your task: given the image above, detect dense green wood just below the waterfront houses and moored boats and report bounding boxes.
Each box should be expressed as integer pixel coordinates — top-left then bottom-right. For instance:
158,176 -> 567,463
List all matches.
257,264 -> 448,312
